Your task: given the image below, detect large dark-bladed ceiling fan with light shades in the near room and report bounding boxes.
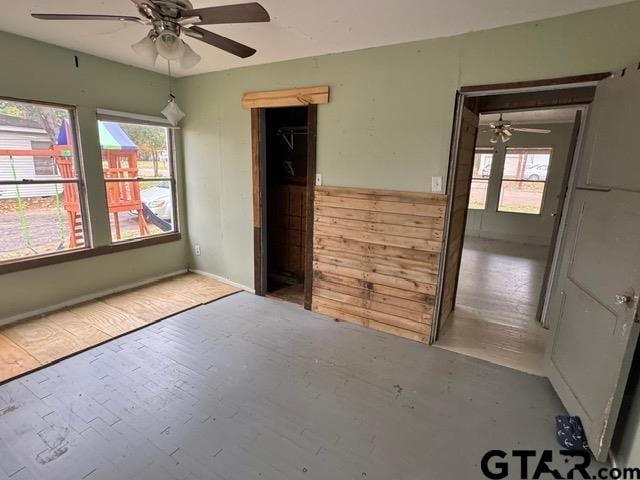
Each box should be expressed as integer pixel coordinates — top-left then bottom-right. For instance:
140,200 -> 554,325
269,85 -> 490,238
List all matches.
31,0 -> 270,69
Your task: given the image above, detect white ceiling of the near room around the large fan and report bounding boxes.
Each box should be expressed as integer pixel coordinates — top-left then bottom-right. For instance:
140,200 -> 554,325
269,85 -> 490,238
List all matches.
0,0 -> 628,75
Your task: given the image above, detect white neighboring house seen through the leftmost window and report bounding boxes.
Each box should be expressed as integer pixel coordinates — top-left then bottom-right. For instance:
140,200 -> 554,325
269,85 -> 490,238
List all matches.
0,114 -> 62,200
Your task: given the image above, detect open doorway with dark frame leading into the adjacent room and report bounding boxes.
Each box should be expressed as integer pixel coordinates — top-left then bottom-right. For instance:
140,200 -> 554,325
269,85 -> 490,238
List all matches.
435,81 -> 595,375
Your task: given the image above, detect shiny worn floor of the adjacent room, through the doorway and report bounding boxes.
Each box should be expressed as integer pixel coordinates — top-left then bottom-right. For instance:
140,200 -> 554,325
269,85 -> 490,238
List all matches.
436,237 -> 548,375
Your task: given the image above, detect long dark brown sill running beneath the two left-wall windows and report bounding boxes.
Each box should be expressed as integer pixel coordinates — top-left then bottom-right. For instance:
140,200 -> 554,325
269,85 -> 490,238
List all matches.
0,232 -> 182,275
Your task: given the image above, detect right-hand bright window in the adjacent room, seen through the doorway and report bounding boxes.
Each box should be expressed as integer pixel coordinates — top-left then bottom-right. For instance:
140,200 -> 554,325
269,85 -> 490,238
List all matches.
498,147 -> 552,215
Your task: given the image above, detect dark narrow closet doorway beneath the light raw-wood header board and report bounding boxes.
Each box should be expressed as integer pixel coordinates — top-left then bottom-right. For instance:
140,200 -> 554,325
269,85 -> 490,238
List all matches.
253,105 -> 317,309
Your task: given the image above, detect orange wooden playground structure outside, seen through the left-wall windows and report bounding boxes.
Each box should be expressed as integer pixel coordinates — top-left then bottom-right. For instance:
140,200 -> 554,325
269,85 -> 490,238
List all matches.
0,122 -> 149,248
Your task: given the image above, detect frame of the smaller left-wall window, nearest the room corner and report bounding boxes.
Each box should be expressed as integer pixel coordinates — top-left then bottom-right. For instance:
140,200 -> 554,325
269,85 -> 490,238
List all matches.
96,114 -> 181,247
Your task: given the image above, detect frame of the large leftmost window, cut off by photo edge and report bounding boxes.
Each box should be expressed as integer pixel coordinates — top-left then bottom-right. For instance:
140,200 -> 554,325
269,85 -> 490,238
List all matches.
0,96 -> 94,266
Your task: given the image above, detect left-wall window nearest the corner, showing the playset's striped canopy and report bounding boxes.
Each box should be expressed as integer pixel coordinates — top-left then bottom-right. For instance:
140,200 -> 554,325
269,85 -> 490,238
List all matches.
98,118 -> 176,242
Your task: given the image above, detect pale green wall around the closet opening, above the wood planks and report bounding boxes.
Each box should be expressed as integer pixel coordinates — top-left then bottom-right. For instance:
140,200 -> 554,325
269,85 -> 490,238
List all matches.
178,1 -> 640,286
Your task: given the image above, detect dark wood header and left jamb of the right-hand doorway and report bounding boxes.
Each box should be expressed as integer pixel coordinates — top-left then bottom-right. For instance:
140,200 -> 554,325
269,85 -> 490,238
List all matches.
430,72 -> 611,343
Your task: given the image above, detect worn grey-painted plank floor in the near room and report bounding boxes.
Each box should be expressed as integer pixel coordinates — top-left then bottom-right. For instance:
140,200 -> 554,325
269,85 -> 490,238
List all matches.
0,293 -> 592,480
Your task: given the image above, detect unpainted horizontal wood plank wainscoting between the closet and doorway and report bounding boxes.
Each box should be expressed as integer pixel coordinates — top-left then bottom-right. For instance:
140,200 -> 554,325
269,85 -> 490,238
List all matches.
312,187 -> 446,342
